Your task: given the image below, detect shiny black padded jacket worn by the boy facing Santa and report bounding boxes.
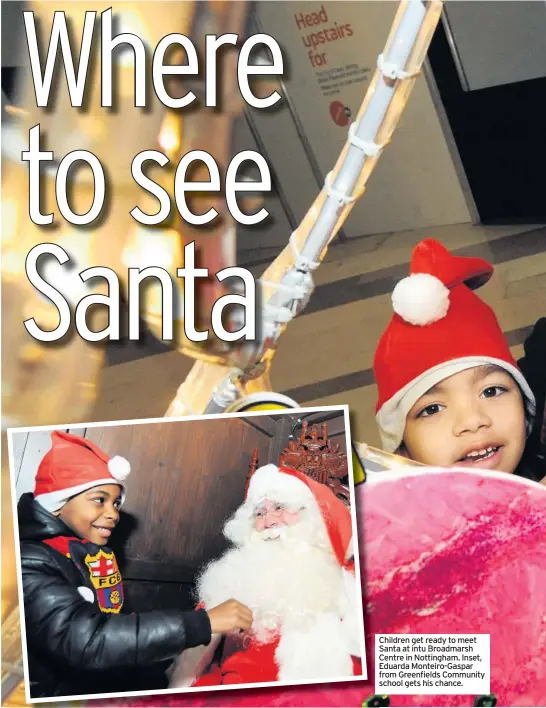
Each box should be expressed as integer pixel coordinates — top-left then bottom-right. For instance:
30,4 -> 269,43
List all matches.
18,494 -> 211,698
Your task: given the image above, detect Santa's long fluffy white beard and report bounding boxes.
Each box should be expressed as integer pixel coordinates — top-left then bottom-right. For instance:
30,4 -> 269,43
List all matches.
198,518 -> 343,640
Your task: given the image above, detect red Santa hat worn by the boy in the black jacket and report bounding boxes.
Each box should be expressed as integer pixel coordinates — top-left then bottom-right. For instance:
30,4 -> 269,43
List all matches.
34,430 -> 131,512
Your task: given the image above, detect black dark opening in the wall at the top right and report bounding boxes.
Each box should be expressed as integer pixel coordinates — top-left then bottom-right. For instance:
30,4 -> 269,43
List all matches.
428,6 -> 546,224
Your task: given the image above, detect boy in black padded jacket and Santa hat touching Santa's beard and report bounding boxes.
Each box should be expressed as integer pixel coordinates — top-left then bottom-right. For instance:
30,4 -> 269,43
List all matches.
18,431 -> 252,698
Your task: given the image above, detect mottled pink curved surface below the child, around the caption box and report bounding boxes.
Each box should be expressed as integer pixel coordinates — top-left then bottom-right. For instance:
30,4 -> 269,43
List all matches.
95,471 -> 546,706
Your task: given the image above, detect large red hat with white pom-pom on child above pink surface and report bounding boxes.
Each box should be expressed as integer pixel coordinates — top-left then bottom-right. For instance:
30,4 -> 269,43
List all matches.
374,239 -> 535,452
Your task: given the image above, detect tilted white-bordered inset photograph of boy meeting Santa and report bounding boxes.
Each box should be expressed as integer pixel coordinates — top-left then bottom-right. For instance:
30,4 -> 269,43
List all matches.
9,407 -> 366,702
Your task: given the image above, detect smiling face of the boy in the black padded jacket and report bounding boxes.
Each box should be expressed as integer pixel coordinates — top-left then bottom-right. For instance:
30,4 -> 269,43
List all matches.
55,484 -> 121,546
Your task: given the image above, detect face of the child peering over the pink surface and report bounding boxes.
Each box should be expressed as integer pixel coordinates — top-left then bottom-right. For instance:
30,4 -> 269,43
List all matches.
403,366 -> 526,472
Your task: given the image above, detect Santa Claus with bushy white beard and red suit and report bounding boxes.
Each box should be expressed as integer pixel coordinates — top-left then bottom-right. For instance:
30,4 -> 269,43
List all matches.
171,465 -> 362,688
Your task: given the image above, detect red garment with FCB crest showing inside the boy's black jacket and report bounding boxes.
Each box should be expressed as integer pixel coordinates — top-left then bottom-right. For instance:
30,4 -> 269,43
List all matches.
44,536 -> 123,614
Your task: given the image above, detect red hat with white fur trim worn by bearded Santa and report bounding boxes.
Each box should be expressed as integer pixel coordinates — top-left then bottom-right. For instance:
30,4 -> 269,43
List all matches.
224,464 -> 353,569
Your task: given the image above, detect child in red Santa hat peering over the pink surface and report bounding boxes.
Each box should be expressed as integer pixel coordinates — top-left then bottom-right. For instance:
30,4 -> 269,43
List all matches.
374,239 -> 546,481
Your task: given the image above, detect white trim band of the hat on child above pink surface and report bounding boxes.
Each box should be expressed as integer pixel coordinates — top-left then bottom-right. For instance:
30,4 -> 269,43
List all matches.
376,356 -> 536,452
